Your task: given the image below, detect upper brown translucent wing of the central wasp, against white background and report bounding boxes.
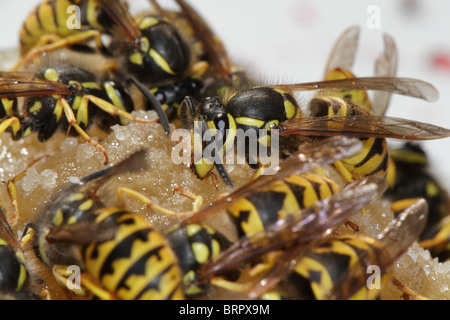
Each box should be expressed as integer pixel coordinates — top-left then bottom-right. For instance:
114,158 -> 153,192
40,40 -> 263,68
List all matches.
268,77 -> 439,102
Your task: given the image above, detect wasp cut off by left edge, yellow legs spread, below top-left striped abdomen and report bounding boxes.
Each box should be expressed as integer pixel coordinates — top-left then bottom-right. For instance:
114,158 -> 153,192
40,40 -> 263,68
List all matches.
0,61 -> 160,164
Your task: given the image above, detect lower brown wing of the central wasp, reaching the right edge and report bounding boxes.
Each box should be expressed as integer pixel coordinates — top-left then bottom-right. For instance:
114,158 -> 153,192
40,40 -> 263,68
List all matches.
280,115 -> 450,140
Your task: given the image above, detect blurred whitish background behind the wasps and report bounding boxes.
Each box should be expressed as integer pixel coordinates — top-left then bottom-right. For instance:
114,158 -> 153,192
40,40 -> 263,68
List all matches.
0,0 -> 450,189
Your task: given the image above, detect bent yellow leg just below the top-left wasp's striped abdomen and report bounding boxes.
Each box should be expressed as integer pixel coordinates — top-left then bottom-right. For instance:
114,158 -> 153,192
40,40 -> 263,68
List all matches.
11,30 -> 103,71
